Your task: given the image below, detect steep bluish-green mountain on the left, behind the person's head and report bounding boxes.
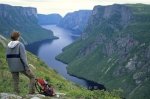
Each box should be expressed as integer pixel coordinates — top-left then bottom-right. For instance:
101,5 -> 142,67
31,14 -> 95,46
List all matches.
0,4 -> 55,43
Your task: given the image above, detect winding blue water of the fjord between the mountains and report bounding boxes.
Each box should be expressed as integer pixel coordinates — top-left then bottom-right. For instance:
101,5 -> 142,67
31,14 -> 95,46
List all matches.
26,25 -> 105,88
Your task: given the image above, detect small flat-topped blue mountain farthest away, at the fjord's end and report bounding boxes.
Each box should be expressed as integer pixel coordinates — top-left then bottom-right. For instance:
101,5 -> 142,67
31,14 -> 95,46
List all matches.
37,14 -> 62,25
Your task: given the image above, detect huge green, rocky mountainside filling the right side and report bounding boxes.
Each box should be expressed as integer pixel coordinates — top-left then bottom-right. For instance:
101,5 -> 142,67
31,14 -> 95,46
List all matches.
57,4 -> 150,99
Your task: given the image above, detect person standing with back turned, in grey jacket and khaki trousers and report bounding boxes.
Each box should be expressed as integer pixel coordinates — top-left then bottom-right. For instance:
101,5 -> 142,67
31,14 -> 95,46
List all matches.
6,31 -> 35,94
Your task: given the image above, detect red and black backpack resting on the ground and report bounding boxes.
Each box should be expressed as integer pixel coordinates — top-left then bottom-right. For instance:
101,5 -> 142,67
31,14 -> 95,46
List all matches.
35,78 -> 55,96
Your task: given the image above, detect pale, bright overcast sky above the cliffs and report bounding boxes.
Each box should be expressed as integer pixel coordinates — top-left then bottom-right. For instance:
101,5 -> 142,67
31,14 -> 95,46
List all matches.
0,0 -> 150,16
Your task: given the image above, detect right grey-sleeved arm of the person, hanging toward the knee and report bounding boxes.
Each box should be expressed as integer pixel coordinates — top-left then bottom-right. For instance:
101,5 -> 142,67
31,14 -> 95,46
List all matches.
19,43 -> 29,70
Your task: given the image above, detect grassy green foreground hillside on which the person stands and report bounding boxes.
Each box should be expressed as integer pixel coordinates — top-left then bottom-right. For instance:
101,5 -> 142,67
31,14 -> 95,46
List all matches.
0,35 -> 120,99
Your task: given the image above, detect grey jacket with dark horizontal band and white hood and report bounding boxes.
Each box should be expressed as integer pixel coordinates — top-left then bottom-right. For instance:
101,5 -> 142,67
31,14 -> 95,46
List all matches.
6,41 -> 29,72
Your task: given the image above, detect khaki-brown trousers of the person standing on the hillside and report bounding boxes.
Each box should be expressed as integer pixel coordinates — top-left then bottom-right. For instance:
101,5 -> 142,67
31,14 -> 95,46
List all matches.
11,70 -> 35,94
